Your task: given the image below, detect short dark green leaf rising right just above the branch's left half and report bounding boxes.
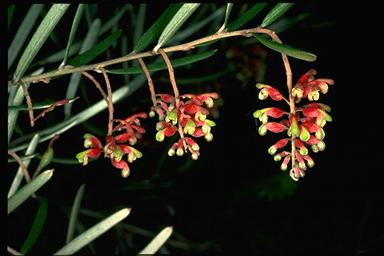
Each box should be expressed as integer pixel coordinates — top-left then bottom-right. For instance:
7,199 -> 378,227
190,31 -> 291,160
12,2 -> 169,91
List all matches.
68,30 -> 121,66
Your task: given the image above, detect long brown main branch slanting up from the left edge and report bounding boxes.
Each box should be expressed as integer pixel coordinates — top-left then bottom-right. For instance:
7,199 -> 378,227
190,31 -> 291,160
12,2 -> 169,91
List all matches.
8,27 -> 265,86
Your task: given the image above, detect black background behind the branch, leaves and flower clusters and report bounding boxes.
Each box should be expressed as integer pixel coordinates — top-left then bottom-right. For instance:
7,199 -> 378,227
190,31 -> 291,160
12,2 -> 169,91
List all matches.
7,3 -> 384,255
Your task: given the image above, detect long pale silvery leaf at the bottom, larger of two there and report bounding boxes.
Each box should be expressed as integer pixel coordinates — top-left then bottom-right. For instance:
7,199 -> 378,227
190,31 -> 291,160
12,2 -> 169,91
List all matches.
54,208 -> 131,255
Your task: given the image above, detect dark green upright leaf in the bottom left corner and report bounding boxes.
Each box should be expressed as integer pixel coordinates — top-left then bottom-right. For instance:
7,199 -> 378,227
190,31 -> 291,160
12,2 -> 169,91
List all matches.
20,198 -> 48,254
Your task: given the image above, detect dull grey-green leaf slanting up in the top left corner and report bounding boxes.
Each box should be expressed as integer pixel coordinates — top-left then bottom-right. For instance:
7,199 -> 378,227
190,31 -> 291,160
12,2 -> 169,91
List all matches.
8,4 -> 44,69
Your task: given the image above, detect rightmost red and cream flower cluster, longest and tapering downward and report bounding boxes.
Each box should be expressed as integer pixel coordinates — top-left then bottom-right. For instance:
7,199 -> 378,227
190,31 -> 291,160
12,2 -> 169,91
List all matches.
253,69 -> 334,181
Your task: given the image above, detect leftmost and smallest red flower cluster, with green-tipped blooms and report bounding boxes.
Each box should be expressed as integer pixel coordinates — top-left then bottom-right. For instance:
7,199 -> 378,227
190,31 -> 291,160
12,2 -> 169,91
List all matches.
76,112 -> 147,178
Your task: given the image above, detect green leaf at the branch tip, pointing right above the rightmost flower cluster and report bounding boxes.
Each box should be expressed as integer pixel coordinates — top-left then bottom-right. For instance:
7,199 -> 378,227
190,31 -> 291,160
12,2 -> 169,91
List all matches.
254,34 -> 317,61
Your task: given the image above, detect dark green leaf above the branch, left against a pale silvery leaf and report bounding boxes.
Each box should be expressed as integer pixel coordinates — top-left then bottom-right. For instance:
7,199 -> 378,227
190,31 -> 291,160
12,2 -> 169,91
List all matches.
133,4 -> 181,52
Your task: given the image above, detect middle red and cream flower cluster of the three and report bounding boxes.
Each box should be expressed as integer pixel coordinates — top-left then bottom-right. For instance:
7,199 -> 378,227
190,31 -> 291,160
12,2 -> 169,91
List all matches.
150,93 -> 218,160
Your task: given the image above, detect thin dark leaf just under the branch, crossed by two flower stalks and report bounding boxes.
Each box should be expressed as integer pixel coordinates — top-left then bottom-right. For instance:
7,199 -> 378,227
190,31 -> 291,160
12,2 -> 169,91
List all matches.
107,50 -> 217,75
